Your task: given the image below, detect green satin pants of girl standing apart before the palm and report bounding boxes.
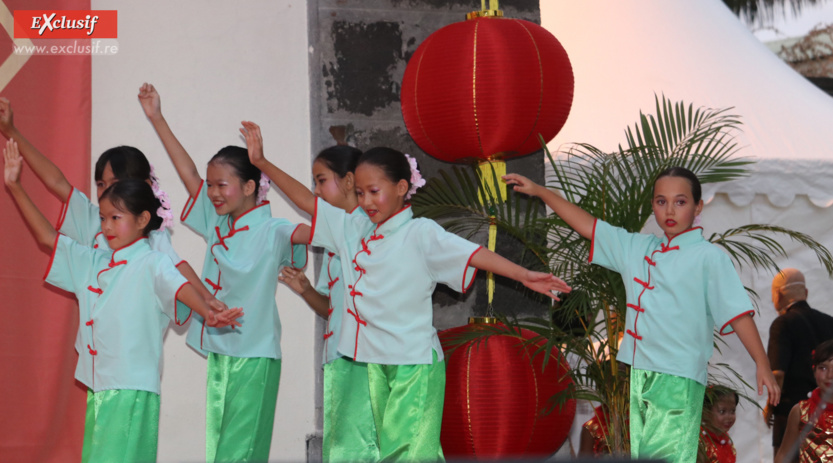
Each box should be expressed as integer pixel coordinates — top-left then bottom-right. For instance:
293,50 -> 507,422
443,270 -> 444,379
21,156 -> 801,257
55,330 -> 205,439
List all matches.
630,368 -> 706,463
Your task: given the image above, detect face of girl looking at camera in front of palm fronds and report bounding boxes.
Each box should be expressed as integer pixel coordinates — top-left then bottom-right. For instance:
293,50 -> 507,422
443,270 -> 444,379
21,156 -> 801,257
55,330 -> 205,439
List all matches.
651,177 -> 703,239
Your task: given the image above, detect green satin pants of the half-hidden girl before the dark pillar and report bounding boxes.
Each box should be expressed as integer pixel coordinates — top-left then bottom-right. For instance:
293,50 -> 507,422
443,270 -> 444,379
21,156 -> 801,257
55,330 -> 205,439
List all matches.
322,357 -> 379,463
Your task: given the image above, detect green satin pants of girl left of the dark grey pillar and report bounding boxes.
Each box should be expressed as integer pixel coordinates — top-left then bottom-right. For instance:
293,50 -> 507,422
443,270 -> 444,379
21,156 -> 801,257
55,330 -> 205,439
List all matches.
205,353 -> 281,463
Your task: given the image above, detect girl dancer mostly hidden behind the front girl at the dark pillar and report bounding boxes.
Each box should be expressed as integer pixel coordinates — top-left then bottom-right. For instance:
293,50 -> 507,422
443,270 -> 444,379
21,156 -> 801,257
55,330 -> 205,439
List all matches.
274,144 -> 379,462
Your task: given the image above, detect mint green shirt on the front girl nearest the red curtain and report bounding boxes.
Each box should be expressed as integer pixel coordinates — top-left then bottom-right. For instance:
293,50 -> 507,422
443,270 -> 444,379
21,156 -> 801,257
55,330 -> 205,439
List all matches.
44,234 -> 188,394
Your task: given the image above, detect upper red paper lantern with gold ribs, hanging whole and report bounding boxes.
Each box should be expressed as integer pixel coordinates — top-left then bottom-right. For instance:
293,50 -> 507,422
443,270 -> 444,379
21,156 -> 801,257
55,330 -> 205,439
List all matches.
401,17 -> 573,162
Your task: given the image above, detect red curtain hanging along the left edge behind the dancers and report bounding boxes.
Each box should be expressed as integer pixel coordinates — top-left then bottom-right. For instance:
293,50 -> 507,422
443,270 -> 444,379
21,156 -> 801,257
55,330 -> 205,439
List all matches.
0,0 -> 91,463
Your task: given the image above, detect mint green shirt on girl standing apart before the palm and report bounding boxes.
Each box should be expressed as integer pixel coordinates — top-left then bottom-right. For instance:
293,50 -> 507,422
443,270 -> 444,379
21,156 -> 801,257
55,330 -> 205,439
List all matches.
590,220 -> 754,385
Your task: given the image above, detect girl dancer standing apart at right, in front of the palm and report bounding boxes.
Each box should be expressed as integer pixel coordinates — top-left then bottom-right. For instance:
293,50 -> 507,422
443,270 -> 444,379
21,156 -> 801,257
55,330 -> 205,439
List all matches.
503,167 -> 780,463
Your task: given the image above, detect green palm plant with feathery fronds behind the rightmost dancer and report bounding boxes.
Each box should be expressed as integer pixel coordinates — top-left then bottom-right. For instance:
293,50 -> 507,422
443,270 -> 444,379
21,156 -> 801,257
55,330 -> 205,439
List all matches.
412,96 -> 833,453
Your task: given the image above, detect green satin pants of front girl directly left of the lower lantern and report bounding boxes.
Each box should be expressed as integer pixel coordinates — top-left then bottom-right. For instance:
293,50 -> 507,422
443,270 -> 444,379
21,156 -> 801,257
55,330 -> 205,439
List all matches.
367,352 -> 445,462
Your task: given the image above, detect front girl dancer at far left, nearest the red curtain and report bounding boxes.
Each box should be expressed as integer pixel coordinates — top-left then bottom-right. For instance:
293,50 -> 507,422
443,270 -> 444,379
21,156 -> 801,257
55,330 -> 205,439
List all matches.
4,140 -> 242,462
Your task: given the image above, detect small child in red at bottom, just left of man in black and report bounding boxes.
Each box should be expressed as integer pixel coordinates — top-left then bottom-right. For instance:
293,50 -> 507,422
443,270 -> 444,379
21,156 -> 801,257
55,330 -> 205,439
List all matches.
697,386 -> 739,463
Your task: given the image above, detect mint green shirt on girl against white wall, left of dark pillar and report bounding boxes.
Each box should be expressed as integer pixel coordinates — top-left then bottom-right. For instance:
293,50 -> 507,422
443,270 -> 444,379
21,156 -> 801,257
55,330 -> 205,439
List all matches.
182,182 -> 307,359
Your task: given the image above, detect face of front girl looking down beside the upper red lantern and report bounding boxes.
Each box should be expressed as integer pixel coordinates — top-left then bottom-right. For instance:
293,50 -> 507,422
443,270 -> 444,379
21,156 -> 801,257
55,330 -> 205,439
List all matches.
356,164 -> 408,224
